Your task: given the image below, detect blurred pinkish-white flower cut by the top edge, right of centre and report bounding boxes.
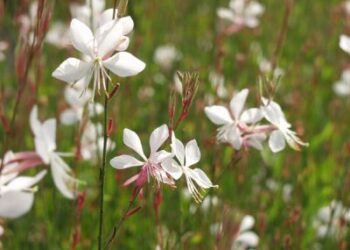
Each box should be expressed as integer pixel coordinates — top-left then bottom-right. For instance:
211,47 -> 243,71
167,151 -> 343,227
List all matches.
217,0 -> 265,28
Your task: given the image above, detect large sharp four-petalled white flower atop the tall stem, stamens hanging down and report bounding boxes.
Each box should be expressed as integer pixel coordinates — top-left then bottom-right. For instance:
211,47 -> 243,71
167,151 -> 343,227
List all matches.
52,14 -> 145,99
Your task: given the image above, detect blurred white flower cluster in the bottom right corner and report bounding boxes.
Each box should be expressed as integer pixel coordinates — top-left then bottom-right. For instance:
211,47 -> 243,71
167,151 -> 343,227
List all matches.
313,200 -> 350,238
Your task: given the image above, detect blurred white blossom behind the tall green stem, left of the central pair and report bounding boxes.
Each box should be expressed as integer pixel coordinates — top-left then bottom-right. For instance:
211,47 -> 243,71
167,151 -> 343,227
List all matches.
80,122 -> 115,161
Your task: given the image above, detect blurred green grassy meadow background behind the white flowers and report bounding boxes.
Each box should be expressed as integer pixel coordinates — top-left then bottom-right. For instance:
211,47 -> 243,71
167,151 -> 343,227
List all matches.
0,0 -> 350,250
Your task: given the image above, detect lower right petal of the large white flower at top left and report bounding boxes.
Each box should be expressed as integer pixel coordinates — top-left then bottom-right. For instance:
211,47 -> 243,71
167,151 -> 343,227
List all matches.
103,52 -> 146,77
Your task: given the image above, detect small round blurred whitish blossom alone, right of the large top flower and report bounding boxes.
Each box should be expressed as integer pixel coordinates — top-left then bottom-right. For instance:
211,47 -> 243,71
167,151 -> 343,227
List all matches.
154,44 -> 181,70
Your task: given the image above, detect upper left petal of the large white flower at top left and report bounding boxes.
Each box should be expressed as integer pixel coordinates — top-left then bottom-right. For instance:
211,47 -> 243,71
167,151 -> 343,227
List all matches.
69,18 -> 94,56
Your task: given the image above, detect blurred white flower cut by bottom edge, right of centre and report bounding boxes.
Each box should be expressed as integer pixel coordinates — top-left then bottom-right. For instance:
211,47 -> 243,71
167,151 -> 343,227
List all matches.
231,215 -> 259,250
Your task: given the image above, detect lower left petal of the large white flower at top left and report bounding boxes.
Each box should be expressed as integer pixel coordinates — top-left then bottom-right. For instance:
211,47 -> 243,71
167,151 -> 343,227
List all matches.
52,57 -> 92,83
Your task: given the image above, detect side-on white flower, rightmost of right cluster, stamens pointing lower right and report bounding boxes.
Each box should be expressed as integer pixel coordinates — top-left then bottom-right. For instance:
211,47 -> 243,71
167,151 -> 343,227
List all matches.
261,98 -> 308,153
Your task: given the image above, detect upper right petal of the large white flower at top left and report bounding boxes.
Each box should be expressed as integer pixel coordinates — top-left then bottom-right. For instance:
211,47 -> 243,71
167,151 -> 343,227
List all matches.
95,20 -> 123,58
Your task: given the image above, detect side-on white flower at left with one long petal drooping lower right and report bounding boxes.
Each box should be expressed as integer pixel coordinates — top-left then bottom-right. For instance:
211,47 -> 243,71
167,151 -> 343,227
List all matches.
30,106 -> 78,199
